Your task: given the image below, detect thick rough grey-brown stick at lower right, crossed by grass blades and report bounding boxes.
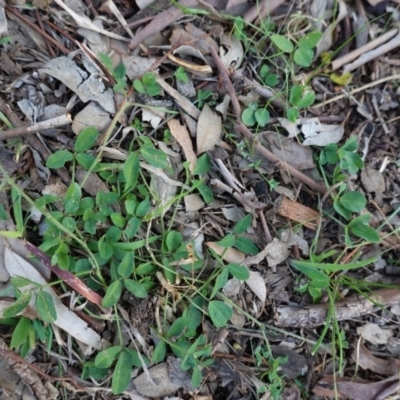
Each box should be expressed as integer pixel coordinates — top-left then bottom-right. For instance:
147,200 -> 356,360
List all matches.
274,289 -> 400,328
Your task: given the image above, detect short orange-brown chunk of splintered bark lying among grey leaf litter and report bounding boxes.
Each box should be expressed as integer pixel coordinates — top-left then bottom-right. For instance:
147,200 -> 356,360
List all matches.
274,196 -> 321,231
